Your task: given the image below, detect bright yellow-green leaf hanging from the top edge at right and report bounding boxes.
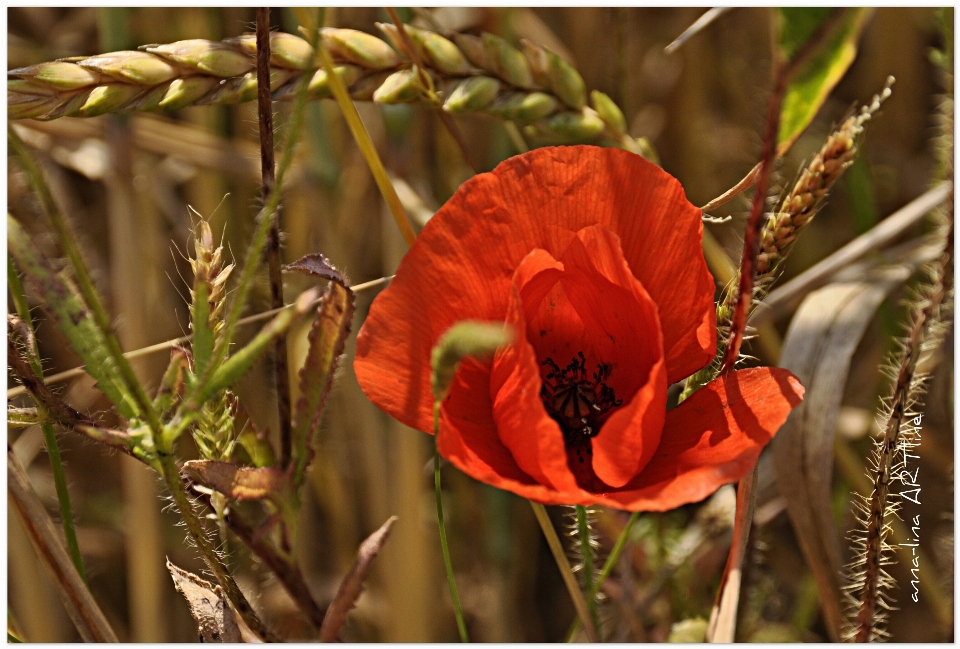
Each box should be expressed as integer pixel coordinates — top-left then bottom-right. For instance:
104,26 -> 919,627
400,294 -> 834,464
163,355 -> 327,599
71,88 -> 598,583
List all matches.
777,7 -> 870,156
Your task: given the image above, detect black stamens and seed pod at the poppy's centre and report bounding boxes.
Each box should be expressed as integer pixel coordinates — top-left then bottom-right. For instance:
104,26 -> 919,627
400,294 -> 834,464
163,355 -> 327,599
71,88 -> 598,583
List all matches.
540,352 -> 623,446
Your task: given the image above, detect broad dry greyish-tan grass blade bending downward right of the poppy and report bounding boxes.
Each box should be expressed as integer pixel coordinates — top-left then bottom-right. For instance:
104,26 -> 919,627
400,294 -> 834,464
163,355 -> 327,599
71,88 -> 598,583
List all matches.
771,266 -> 910,641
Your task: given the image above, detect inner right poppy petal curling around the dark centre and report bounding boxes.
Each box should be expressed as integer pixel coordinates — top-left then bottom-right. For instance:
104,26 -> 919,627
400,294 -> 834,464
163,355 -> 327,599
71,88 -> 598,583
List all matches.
562,226 -> 667,487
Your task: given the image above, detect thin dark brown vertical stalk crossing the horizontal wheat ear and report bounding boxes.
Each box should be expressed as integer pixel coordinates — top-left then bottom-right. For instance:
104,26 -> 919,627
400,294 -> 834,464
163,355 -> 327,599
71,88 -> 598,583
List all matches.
257,7 -> 291,466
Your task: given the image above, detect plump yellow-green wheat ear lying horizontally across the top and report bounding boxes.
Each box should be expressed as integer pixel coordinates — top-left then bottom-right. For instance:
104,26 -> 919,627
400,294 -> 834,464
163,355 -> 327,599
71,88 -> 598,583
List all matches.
7,24 -> 643,153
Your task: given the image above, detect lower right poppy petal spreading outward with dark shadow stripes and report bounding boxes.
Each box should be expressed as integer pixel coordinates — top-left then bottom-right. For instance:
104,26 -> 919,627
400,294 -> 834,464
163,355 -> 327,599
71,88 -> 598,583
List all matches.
597,367 -> 804,511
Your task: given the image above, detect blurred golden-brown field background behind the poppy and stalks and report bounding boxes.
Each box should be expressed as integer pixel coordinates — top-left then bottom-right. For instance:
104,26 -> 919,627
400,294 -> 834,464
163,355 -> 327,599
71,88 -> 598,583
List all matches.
7,7 -> 954,642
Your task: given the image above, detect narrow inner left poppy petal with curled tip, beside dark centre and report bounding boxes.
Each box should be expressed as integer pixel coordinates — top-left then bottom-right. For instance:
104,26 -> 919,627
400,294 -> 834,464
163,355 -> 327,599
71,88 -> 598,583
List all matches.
488,250 -> 577,491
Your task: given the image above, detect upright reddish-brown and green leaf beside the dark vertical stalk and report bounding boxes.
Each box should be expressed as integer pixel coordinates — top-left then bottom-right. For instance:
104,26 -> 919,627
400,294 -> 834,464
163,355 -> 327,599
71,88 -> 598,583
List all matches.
293,282 -> 354,484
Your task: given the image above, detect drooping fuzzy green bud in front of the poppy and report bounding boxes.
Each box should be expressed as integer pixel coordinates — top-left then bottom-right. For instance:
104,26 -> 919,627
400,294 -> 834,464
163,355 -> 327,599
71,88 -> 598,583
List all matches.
430,320 -> 513,401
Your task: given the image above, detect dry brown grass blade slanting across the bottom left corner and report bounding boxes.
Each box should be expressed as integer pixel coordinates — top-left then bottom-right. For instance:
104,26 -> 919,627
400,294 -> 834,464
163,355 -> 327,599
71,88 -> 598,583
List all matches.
7,450 -> 118,642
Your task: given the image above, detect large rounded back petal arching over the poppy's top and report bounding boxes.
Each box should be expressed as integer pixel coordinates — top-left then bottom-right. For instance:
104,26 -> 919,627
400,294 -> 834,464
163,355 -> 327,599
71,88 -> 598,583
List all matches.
354,146 -> 715,431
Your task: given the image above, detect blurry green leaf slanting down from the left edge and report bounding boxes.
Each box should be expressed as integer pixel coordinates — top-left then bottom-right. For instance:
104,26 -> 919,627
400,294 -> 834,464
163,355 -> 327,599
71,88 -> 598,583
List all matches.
7,215 -> 140,419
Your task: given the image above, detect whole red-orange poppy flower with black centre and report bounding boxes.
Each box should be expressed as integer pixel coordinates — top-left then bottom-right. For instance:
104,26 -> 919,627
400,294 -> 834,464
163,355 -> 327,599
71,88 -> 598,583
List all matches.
354,146 -> 803,511
